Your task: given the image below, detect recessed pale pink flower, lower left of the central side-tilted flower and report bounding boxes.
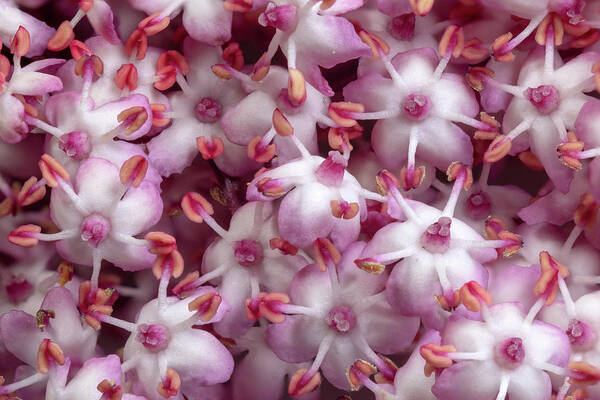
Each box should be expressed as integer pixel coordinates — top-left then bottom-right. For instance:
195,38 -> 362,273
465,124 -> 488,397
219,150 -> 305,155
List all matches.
176,199 -> 306,338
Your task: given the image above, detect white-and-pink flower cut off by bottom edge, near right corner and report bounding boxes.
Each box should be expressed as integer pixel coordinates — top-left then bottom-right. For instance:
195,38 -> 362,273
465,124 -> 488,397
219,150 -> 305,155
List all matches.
428,303 -> 570,400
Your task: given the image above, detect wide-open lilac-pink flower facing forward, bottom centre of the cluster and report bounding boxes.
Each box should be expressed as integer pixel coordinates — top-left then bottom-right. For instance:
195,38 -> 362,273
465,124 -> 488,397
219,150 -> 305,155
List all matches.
267,242 -> 419,395
